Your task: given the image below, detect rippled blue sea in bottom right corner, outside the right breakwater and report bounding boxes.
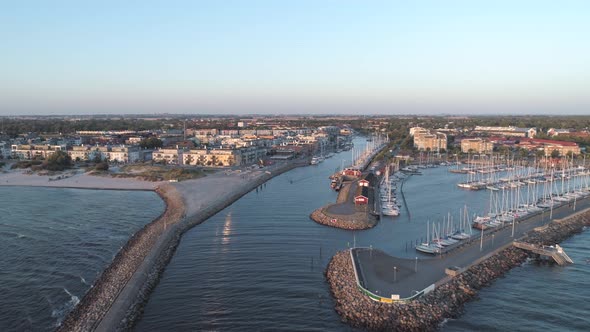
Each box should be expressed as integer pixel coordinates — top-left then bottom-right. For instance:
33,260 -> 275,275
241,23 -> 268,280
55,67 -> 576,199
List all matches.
442,230 -> 590,332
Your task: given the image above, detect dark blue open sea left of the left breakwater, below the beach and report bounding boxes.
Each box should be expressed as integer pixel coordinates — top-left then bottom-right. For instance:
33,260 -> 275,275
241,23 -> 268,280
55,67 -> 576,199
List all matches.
0,187 -> 164,331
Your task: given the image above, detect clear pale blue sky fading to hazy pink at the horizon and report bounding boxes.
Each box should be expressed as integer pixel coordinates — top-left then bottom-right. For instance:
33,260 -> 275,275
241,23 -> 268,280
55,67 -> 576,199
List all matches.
0,0 -> 590,115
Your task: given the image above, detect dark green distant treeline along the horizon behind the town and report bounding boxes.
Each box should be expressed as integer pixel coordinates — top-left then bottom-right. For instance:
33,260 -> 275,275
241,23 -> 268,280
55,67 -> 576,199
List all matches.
0,116 -> 590,139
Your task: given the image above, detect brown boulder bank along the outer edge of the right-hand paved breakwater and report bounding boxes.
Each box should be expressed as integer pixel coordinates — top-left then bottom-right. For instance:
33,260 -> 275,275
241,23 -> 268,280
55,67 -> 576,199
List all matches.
326,210 -> 590,331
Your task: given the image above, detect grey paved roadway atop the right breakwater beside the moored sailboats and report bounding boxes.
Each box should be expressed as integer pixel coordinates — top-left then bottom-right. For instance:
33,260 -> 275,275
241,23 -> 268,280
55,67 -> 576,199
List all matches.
355,198 -> 590,298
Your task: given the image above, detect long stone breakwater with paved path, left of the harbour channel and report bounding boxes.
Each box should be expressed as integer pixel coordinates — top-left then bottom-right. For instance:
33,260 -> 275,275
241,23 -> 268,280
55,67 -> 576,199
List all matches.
58,162 -> 308,331
